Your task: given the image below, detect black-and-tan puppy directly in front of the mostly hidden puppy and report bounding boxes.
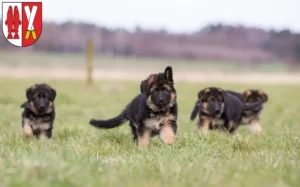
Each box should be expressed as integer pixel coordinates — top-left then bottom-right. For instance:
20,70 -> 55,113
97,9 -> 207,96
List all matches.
190,87 -> 263,134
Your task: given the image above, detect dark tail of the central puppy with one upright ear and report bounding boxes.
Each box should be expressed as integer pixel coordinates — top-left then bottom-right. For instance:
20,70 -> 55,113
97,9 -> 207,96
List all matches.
90,110 -> 127,129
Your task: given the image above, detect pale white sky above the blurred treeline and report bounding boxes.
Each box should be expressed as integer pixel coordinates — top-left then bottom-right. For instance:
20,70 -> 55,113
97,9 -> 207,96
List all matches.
2,0 -> 300,32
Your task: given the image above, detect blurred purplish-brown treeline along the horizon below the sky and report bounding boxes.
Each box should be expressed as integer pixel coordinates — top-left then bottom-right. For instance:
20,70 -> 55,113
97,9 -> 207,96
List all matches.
0,21 -> 300,64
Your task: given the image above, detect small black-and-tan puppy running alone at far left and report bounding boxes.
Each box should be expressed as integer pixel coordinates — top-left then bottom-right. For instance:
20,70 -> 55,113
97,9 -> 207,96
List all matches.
21,83 -> 56,139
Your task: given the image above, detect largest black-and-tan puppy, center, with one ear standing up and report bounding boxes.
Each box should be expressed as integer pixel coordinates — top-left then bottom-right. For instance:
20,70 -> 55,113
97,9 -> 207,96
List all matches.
90,66 -> 178,147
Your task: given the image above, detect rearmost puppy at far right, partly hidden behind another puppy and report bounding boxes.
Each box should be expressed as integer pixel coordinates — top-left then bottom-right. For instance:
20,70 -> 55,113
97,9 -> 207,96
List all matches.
226,89 -> 268,133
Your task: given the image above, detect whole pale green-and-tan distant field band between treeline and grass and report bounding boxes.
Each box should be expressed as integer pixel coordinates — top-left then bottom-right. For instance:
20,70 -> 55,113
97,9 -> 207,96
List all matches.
0,52 -> 300,84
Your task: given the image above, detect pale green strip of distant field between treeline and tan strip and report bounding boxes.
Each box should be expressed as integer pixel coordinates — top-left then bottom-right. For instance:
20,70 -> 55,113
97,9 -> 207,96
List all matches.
0,52 -> 288,72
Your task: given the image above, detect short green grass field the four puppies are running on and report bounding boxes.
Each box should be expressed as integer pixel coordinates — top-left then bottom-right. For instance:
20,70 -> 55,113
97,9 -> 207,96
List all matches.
0,78 -> 300,187
